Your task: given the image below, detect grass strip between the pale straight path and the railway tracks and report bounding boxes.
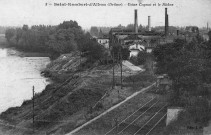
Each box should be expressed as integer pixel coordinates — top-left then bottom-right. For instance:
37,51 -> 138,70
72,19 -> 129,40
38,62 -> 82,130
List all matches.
76,94 -> 153,135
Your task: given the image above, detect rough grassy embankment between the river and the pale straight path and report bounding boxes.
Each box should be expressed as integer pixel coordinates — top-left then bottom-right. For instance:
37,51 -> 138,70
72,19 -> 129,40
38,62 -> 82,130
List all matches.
0,52 -> 154,134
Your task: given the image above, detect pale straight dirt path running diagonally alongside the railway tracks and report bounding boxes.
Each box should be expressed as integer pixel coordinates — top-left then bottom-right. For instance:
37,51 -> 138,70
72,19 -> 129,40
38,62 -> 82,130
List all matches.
66,83 -> 155,135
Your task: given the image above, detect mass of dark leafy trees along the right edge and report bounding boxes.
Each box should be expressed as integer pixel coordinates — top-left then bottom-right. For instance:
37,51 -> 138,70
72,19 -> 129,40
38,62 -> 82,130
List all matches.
153,33 -> 211,124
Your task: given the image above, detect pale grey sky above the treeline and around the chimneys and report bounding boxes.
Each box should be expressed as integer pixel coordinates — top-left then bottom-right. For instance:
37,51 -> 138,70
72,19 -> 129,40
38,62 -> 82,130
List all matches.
0,0 -> 211,29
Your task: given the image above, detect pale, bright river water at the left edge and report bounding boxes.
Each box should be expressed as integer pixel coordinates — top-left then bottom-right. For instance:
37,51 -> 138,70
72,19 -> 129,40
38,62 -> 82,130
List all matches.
0,48 -> 50,113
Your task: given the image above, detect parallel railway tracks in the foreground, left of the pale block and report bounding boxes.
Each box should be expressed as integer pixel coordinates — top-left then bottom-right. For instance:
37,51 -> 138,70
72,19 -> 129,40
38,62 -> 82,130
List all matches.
105,98 -> 167,135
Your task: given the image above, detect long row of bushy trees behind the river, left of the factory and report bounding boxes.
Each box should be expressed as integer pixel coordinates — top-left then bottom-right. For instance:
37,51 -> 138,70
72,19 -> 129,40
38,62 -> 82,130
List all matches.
5,21 -> 103,60
